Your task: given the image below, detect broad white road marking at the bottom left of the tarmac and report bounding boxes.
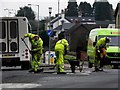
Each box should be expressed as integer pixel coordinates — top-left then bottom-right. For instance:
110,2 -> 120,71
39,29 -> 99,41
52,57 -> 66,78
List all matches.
0,83 -> 42,88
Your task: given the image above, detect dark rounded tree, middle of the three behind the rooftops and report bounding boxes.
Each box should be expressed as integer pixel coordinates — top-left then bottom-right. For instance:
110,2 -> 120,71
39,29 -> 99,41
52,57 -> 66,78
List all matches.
78,2 -> 93,17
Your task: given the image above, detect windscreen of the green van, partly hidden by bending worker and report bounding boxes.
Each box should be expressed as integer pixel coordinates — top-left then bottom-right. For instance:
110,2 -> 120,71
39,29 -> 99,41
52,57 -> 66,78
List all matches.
99,36 -> 120,46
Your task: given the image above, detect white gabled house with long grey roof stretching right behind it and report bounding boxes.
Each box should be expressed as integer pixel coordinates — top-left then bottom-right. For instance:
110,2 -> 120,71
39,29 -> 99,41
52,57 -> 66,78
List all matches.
47,10 -> 95,37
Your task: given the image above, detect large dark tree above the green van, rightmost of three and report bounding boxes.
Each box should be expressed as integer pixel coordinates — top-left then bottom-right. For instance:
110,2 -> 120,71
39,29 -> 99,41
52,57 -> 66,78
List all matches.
93,2 -> 113,21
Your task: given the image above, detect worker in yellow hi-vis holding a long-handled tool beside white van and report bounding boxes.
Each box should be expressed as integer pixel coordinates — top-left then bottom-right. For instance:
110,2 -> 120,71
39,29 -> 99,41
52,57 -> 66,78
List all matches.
24,33 -> 43,73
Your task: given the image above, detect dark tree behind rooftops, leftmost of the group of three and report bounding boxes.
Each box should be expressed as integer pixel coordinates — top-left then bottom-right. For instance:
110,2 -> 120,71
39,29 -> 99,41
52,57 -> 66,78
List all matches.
65,2 -> 78,17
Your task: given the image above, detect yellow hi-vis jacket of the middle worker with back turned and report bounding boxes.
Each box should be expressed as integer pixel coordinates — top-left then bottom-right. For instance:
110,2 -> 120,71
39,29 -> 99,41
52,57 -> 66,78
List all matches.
55,39 -> 69,52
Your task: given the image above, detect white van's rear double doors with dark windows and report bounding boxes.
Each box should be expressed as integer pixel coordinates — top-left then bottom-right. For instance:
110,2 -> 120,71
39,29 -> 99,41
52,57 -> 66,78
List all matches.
0,19 -> 19,54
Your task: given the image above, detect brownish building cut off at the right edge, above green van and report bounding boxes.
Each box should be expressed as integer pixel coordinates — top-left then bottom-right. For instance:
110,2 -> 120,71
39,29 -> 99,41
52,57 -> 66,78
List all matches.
115,2 -> 120,28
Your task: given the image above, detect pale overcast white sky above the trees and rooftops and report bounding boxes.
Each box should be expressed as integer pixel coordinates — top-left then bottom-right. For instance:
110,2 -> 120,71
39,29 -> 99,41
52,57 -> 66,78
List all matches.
0,0 -> 119,19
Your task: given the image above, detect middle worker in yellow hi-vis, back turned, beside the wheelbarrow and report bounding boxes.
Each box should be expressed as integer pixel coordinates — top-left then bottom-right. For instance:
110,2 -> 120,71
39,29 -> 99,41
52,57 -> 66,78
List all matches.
55,34 -> 69,74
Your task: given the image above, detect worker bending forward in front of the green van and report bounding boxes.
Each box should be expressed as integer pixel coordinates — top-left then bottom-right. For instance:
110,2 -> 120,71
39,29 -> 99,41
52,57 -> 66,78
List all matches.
95,37 -> 110,71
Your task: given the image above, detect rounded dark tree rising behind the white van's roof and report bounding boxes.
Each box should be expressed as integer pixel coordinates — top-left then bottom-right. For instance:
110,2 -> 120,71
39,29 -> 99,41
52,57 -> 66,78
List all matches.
16,6 -> 35,20
